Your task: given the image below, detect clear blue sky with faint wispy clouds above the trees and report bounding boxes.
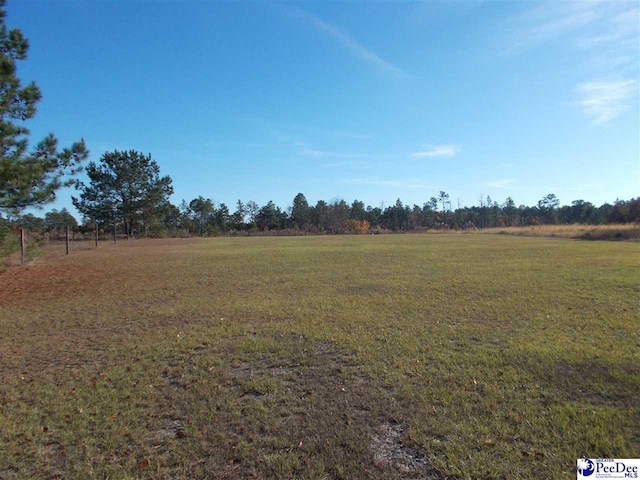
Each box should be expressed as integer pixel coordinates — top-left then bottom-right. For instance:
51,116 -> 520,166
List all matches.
7,0 -> 640,216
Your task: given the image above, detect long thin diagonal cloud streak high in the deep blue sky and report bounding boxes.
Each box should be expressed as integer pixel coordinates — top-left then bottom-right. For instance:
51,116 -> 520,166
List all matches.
282,6 -> 411,78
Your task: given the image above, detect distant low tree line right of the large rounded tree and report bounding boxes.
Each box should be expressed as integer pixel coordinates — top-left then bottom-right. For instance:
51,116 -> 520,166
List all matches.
158,192 -> 640,236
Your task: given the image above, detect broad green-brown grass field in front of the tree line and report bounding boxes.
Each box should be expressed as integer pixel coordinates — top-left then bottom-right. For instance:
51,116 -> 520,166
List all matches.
0,235 -> 640,480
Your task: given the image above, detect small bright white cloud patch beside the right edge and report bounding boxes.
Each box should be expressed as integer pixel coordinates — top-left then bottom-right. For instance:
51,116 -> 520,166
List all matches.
577,79 -> 638,125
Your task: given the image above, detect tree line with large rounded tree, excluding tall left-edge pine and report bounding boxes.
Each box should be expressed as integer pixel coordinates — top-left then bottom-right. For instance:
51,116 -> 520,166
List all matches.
4,146 -> 640,237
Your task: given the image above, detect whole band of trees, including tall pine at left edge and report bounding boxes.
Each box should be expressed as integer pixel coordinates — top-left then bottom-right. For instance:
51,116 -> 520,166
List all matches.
0,0 -> 640,247
